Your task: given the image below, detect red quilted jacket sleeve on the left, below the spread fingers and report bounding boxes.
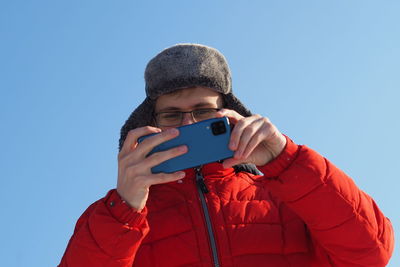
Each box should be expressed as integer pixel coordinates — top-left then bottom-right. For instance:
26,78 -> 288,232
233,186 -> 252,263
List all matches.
59,190 -> 149,267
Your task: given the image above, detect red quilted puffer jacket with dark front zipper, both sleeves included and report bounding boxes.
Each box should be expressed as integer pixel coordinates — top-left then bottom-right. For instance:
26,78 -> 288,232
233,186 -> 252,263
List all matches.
59,140 -> 394,267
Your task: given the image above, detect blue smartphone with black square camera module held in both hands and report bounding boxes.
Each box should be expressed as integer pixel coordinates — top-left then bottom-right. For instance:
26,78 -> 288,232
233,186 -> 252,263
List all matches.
138,117 -> 233,173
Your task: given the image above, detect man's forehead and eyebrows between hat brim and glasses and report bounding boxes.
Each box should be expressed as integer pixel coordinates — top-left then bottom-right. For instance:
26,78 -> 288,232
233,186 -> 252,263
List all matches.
155,87 -> 222,112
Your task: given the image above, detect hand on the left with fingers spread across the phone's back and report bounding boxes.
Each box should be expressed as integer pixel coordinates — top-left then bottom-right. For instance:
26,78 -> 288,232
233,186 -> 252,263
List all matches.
117,126 -> 187,211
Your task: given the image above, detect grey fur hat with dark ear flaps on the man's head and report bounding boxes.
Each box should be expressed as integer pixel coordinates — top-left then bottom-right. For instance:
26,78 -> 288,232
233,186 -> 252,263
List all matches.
119,44 -> 251,150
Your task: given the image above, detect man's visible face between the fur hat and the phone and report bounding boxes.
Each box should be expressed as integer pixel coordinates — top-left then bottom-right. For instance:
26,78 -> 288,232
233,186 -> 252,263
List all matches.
155,87 -> 223,130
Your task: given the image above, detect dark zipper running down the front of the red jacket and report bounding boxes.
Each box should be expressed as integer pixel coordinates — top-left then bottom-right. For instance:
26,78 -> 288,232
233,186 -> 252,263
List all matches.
195,167 -> 220,267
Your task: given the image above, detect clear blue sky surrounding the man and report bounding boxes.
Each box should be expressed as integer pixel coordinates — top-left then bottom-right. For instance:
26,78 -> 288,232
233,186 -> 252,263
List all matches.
0,0 -> 400,267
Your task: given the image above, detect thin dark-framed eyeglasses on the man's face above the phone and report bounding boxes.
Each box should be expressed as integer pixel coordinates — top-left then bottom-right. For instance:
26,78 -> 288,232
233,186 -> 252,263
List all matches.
154,108 -> 221,127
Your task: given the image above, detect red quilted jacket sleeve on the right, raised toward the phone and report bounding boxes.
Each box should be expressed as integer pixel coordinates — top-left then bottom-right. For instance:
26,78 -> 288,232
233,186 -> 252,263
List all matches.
258,138 -> 394,266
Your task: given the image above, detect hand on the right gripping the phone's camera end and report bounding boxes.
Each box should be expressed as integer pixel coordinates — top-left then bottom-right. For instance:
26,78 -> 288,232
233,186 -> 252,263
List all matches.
217,109 -> 286,168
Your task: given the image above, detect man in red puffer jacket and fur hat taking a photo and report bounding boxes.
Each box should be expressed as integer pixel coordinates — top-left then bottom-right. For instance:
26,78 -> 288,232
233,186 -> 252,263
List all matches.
60,44 -> 393,267
